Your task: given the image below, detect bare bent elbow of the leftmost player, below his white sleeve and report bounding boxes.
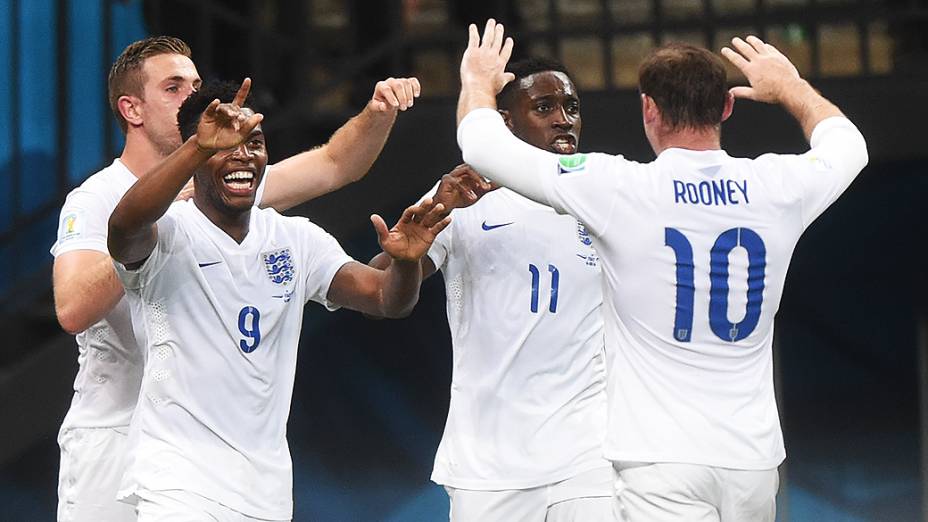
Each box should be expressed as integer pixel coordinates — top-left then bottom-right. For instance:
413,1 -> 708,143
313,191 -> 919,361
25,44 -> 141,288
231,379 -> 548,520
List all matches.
52,253 -> 124,335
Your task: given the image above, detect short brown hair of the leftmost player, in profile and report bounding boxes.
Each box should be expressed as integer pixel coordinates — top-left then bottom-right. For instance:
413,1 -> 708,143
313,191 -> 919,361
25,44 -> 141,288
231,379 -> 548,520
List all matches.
106,36 -> 191,132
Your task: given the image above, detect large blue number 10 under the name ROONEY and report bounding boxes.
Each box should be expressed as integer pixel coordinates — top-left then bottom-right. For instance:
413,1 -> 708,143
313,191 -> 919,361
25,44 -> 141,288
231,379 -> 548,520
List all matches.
664,228 -> 767,342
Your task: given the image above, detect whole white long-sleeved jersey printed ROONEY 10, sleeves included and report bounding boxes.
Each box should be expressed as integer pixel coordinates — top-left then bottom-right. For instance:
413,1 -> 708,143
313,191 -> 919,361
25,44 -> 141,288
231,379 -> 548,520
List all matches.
459,110 -> 867,470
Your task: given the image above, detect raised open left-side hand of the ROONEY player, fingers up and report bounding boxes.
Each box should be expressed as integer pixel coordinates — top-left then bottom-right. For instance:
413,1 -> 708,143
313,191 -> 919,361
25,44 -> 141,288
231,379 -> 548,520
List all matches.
461,18 -> 515,95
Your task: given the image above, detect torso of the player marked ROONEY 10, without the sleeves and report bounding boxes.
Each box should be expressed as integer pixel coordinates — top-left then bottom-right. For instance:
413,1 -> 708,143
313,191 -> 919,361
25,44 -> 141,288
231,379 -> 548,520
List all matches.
597,149 -> 802,468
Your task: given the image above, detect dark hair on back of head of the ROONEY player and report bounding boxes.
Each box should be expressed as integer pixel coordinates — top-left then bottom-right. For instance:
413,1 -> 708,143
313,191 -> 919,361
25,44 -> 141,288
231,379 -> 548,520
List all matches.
638,43 -> 728,129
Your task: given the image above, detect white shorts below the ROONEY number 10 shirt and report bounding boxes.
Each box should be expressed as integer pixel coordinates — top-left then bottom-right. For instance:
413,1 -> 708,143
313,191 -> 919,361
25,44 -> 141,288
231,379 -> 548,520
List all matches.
613,462 -> 780,522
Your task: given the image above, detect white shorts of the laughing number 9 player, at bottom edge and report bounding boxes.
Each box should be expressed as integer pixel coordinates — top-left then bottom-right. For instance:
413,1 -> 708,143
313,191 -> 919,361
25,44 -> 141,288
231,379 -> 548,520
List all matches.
135,489 -> 286,522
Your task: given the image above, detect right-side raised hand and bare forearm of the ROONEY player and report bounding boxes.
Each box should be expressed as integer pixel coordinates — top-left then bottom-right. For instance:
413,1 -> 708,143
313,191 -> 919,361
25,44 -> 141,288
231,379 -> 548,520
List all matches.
722,36 -> 844,140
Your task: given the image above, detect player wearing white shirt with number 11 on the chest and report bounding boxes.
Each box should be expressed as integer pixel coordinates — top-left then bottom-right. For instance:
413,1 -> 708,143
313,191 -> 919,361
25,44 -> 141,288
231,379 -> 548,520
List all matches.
366,59 -> 612,522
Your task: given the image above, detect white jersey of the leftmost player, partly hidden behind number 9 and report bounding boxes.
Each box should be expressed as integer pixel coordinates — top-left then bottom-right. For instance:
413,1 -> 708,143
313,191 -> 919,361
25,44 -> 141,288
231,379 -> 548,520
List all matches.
51,158 -> 267,431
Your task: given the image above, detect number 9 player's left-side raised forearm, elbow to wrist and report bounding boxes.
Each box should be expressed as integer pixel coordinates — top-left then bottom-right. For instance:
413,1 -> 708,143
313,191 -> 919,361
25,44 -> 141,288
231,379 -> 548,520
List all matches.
107,135 -> 212,264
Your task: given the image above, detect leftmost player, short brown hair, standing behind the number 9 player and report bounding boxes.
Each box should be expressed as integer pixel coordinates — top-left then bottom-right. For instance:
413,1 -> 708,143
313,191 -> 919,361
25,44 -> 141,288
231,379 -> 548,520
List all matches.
51,37 -> 419,522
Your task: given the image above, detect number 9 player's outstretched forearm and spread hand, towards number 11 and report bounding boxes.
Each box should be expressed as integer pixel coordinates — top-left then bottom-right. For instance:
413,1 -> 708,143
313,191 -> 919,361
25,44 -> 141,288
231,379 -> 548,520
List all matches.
327,199 -> 451,318
